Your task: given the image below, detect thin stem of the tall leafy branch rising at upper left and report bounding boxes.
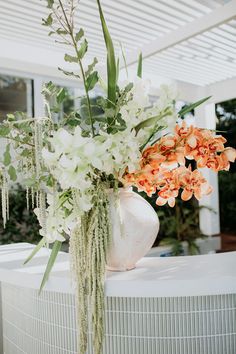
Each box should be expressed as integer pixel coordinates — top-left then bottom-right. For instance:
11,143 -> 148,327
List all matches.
59,0 -> 95,137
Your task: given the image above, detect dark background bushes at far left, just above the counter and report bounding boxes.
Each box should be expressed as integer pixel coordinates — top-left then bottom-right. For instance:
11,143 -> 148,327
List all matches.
0,186 -> 41,244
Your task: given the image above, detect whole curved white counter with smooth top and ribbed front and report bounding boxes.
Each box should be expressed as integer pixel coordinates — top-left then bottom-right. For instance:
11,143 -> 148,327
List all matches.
0,244 -> 236,354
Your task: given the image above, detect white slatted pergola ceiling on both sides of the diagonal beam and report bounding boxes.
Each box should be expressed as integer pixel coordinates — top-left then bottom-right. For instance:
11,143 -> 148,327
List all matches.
0,0 -> 236,86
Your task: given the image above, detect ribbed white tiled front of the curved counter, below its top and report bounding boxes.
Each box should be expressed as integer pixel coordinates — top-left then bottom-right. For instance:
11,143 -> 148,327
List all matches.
2,283 -> 236,354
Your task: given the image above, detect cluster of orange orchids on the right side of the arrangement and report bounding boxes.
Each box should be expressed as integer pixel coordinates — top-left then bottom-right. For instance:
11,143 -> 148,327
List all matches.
124,122 -> 236,207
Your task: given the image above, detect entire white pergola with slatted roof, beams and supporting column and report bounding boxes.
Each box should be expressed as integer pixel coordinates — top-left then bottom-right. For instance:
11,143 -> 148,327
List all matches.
0,0 -> 236,235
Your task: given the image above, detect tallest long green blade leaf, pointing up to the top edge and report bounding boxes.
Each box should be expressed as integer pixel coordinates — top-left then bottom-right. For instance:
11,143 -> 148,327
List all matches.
97,0 -> 117,107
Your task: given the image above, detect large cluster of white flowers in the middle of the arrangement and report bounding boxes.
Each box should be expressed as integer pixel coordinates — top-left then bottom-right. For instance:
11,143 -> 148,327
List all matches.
39,79 -> 178,242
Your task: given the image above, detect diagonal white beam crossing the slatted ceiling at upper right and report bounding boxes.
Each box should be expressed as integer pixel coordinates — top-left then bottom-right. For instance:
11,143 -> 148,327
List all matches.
123,0 -> 236,65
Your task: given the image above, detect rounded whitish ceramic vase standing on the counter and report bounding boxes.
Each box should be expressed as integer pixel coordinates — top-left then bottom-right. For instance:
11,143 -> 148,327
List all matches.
107,188 -> 159,271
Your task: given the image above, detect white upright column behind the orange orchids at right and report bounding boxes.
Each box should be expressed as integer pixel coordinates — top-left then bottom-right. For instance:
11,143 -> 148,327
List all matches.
195,103 -> 220,236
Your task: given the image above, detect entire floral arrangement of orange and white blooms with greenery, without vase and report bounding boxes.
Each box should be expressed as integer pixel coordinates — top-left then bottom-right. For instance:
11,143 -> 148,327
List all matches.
0,0 -> 236,354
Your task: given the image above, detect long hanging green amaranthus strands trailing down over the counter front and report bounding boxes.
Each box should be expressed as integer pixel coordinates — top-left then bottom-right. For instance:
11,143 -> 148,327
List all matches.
70,180 -> 111,354
